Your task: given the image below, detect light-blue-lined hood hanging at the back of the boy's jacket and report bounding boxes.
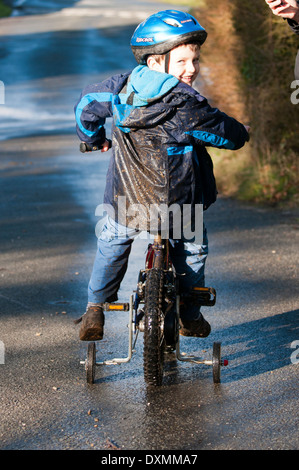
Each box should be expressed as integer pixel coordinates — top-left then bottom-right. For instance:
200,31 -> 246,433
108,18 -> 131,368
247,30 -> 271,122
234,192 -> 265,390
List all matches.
113,65 -> 179,132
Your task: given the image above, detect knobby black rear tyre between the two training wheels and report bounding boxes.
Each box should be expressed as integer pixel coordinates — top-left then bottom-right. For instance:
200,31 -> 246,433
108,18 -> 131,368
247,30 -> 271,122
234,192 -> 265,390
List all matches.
143,268 -> 164,386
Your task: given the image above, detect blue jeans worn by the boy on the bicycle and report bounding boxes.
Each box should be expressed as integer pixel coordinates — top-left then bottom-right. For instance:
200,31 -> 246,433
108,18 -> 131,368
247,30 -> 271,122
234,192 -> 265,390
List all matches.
88,216 -> 208,320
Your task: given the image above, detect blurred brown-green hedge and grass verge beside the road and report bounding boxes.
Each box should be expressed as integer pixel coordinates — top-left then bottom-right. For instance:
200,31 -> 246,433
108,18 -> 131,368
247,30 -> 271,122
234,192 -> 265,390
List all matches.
190,0 -> 299,205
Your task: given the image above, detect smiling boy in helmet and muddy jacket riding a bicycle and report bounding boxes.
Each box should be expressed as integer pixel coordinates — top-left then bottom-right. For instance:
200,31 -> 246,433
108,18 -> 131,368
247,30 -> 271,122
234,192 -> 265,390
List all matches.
75,10 -> 249,341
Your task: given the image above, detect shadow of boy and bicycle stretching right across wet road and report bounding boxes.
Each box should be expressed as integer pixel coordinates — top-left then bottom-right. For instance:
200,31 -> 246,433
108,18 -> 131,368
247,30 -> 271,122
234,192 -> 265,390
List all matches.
85,310 -> 299,388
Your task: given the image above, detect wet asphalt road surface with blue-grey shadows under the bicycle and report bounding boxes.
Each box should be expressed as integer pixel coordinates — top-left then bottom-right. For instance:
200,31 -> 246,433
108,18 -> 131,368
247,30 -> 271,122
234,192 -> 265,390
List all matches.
0,1 -> 299,451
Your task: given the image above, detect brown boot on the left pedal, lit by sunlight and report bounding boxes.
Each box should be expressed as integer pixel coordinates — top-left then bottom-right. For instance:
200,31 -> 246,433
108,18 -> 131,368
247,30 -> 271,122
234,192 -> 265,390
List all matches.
75,305 -> 105,341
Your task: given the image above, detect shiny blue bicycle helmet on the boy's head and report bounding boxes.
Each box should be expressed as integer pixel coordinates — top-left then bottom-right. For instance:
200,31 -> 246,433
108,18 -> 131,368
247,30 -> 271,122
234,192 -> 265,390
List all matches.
131,10 -> 207,64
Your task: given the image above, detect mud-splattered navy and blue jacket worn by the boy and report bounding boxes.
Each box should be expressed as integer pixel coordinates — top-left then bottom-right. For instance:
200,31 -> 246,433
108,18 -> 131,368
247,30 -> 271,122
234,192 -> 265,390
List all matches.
75,66 -> 248,229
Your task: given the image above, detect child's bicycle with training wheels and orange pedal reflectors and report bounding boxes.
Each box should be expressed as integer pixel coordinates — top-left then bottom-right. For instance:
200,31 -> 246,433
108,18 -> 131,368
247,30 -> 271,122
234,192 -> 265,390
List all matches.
80,144 -> 228,386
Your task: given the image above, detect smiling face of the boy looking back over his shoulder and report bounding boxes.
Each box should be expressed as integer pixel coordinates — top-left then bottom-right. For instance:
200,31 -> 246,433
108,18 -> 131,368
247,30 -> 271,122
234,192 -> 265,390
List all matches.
148,44 -> 199,86
